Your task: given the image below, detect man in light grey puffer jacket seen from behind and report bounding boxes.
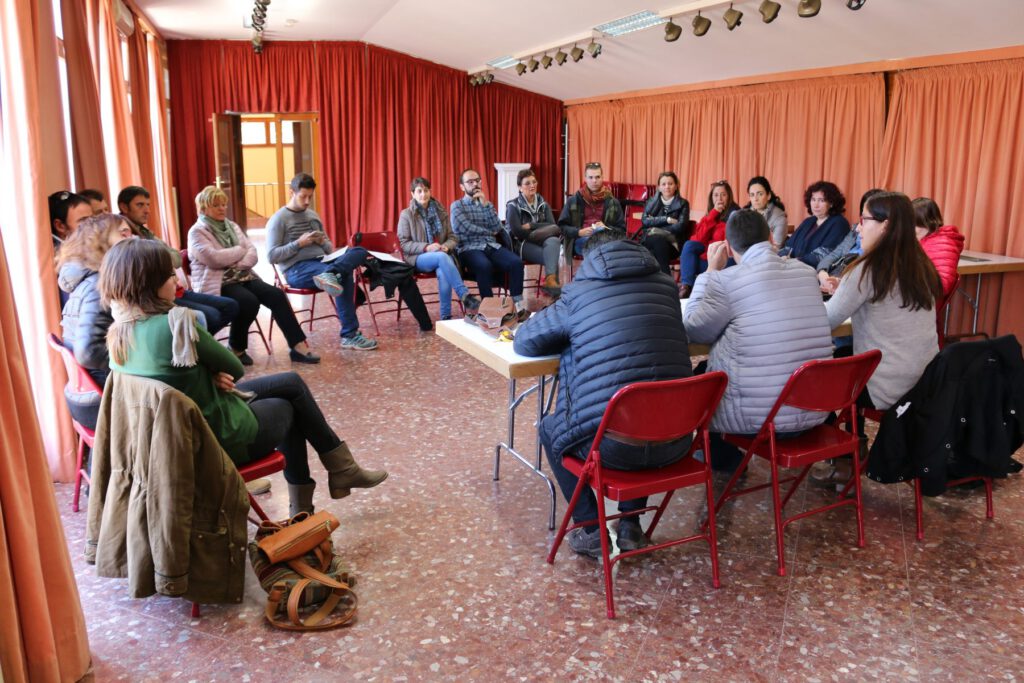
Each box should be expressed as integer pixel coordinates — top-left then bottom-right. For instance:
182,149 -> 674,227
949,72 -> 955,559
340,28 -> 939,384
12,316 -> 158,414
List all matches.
683,209 -> 831,472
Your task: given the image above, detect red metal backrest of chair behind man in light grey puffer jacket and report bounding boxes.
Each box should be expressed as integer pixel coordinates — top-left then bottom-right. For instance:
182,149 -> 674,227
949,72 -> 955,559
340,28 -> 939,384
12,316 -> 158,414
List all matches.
761,349 -> 882,432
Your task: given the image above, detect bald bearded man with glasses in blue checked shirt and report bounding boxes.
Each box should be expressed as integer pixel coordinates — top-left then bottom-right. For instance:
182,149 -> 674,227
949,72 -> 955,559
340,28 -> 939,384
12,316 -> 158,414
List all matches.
451,168 -> 529,323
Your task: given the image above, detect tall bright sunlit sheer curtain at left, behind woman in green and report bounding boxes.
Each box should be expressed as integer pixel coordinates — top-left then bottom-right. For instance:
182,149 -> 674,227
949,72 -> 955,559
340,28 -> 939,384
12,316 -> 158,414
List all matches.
0,0 -> 75,481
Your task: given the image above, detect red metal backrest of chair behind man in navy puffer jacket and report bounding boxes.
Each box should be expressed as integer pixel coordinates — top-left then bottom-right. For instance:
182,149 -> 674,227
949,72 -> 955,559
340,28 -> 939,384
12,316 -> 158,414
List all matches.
594,372 -> 729,447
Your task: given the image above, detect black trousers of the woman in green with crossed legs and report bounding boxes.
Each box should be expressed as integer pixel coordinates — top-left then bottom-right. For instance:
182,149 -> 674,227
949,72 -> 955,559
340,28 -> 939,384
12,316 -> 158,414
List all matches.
238,373 -> 341,484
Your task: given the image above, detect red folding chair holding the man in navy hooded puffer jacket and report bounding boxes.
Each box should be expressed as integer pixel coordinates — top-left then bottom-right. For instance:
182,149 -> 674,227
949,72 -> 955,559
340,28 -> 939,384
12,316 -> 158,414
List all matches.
548,372 -> 728,618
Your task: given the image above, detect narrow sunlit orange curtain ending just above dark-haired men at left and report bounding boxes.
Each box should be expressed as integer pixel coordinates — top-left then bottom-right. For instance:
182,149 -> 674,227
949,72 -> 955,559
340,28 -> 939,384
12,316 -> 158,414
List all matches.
97,0 -> 142,200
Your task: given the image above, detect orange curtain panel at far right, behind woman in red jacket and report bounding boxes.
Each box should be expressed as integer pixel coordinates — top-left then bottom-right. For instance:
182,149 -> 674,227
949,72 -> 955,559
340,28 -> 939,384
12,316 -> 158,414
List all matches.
881,59 -> 1024,337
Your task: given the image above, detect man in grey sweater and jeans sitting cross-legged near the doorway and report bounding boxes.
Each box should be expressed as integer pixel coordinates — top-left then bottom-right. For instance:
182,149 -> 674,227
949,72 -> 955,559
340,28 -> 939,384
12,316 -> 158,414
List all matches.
266,173 -> 432,351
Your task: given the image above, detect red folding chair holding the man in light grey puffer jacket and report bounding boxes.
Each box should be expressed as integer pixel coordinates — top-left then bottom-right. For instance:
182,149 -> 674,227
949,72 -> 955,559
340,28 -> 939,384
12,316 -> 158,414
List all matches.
715,349 -> 882,577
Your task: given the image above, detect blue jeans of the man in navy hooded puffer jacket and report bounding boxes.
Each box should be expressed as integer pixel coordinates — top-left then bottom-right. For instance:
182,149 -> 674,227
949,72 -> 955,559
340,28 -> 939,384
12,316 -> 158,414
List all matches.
537,413 -> 693,531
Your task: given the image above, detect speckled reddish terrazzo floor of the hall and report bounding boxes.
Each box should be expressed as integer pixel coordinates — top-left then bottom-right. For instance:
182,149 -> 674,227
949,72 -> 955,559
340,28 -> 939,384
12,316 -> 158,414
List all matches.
56,248 -> 1024,681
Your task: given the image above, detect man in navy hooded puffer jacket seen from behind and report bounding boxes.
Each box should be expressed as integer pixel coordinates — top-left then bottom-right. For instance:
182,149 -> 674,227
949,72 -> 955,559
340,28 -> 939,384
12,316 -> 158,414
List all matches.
514,230 -> 696,558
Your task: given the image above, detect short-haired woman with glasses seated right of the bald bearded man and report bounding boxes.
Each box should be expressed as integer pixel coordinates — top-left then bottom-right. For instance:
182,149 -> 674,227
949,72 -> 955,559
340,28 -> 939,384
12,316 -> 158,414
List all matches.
505,168 -> 562,299
